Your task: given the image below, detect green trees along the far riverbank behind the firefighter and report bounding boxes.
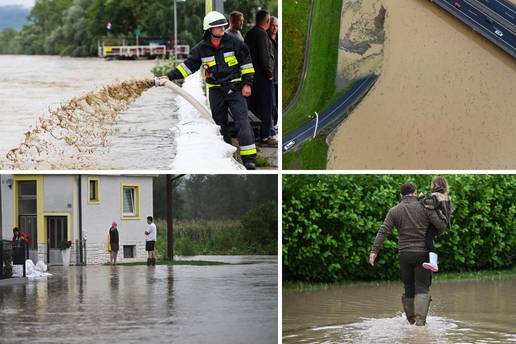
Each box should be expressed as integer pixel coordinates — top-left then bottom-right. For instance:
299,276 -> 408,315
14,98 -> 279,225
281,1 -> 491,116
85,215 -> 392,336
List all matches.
0,0 -> 277,56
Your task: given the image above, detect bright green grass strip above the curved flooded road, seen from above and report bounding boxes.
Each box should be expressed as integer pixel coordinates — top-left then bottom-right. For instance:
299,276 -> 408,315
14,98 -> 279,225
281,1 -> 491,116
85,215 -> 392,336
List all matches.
283,0 -> 342,135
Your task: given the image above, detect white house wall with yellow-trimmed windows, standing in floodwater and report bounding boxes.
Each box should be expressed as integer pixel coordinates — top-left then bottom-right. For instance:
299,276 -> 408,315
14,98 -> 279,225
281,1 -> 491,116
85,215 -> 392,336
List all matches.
0,175 -> 153,264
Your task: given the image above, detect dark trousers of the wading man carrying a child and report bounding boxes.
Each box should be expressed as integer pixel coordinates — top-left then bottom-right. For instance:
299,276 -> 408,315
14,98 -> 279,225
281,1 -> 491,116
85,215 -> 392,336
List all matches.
400,252 -> 432,298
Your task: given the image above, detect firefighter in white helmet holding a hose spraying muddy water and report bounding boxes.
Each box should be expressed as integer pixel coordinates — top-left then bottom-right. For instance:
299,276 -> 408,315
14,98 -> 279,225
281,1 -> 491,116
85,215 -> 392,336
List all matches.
160,11 -> 256,170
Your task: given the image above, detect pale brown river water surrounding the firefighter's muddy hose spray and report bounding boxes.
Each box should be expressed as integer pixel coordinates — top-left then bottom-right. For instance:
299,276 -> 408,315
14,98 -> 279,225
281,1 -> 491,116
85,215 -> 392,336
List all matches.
0,55 -> 178,169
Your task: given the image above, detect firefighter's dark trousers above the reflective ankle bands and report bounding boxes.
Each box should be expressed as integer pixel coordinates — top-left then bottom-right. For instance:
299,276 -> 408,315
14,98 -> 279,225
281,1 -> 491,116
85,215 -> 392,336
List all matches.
209,84 -> 254,154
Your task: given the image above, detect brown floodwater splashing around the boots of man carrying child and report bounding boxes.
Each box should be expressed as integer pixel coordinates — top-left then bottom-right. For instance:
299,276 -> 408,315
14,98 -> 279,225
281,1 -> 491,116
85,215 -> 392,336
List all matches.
283,279 -> 516,343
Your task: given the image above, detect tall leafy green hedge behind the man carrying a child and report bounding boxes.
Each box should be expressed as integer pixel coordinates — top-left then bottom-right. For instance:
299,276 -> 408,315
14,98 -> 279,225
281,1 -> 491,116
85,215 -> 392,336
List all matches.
283,175 -> 516,282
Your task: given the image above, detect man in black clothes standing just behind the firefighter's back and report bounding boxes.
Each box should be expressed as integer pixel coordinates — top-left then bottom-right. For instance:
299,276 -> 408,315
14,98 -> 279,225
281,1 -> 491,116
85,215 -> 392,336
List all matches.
245,10 -> 278,147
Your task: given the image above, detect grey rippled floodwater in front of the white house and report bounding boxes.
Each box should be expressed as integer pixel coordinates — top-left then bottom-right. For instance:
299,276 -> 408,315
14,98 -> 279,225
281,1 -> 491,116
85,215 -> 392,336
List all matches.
0,257 -> 278,343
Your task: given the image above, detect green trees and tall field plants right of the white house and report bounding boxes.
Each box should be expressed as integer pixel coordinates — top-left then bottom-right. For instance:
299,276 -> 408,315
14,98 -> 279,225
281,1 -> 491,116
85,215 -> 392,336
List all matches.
153,175 -> 278,256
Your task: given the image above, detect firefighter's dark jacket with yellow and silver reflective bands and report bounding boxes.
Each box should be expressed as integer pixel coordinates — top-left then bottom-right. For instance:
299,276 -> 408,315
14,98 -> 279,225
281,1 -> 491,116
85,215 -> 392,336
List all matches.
167,31 -> 254,87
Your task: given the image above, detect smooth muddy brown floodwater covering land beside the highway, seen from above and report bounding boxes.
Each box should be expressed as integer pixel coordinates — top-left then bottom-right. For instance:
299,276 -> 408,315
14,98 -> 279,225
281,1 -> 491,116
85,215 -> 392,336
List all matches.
328,0 -> 516,169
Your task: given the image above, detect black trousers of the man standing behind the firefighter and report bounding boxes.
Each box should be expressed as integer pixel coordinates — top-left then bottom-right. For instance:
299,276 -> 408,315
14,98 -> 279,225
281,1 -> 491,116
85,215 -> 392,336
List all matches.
247,73 -> 274,140
